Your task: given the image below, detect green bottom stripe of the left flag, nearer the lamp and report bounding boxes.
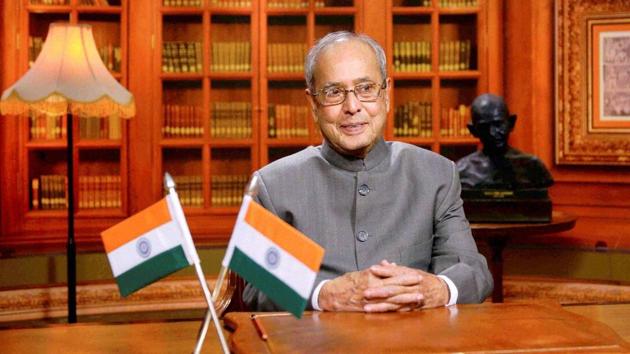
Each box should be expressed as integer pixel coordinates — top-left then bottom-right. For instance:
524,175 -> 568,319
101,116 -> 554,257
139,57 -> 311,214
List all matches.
116,245 -> 189,297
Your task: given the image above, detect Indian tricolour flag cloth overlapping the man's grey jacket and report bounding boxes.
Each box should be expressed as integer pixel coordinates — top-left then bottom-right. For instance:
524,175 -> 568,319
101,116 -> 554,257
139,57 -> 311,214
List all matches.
223,196 -> 324,318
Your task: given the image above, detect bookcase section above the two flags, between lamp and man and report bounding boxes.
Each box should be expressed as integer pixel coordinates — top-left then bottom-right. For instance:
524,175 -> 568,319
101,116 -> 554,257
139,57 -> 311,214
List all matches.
153,0 -> 259,224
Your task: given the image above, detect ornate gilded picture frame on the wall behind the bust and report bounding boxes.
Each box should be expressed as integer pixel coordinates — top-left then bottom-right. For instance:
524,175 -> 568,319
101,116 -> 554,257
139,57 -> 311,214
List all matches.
555,0 -> 630,166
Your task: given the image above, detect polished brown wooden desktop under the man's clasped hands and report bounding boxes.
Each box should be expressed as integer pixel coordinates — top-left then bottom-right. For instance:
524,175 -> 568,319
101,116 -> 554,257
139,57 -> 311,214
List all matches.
224,303 -> 630,353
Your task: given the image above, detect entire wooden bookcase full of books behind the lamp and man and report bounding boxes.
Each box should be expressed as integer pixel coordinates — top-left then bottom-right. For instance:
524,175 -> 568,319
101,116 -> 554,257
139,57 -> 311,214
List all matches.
0,0 -> 501,249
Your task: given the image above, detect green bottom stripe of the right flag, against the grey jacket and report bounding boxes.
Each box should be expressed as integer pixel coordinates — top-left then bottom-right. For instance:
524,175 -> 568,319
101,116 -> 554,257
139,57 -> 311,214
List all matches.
229,247 -> 306,318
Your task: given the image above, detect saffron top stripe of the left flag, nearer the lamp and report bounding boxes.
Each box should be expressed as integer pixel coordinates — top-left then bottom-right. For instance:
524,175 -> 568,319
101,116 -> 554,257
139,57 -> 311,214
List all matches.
101,199 -> 171,253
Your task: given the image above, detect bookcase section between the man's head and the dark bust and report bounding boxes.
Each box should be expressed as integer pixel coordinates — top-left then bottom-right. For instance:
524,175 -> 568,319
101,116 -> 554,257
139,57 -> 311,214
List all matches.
387,0 -> 488,160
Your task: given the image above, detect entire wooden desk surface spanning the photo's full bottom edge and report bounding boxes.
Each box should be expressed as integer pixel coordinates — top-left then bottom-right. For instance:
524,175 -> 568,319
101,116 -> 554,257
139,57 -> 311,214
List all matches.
0,303 -> 630,354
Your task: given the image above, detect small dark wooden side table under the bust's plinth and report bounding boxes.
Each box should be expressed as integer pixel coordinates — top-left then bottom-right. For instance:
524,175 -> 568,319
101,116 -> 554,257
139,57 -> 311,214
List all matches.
470,211 -> 576,302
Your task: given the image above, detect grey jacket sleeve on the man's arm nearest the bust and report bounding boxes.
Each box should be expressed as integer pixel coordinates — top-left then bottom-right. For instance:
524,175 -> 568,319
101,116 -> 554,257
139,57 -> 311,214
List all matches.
429,164 -> 493,303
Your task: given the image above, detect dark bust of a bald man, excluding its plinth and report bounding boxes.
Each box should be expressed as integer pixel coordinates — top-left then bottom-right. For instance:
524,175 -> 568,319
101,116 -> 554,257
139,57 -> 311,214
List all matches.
457,94 -> 553,190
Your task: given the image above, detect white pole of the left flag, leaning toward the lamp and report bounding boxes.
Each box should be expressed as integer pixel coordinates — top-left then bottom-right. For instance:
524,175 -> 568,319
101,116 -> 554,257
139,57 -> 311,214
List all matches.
164,172 -> 230,354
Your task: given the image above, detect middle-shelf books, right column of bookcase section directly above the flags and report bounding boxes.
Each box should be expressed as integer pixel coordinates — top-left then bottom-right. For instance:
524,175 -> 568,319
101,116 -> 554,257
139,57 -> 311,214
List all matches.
210,102 -> 252,138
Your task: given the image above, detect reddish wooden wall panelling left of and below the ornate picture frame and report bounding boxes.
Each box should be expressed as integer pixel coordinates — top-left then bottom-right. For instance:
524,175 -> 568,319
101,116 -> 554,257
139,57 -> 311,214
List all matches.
504,0 -> 630,249
